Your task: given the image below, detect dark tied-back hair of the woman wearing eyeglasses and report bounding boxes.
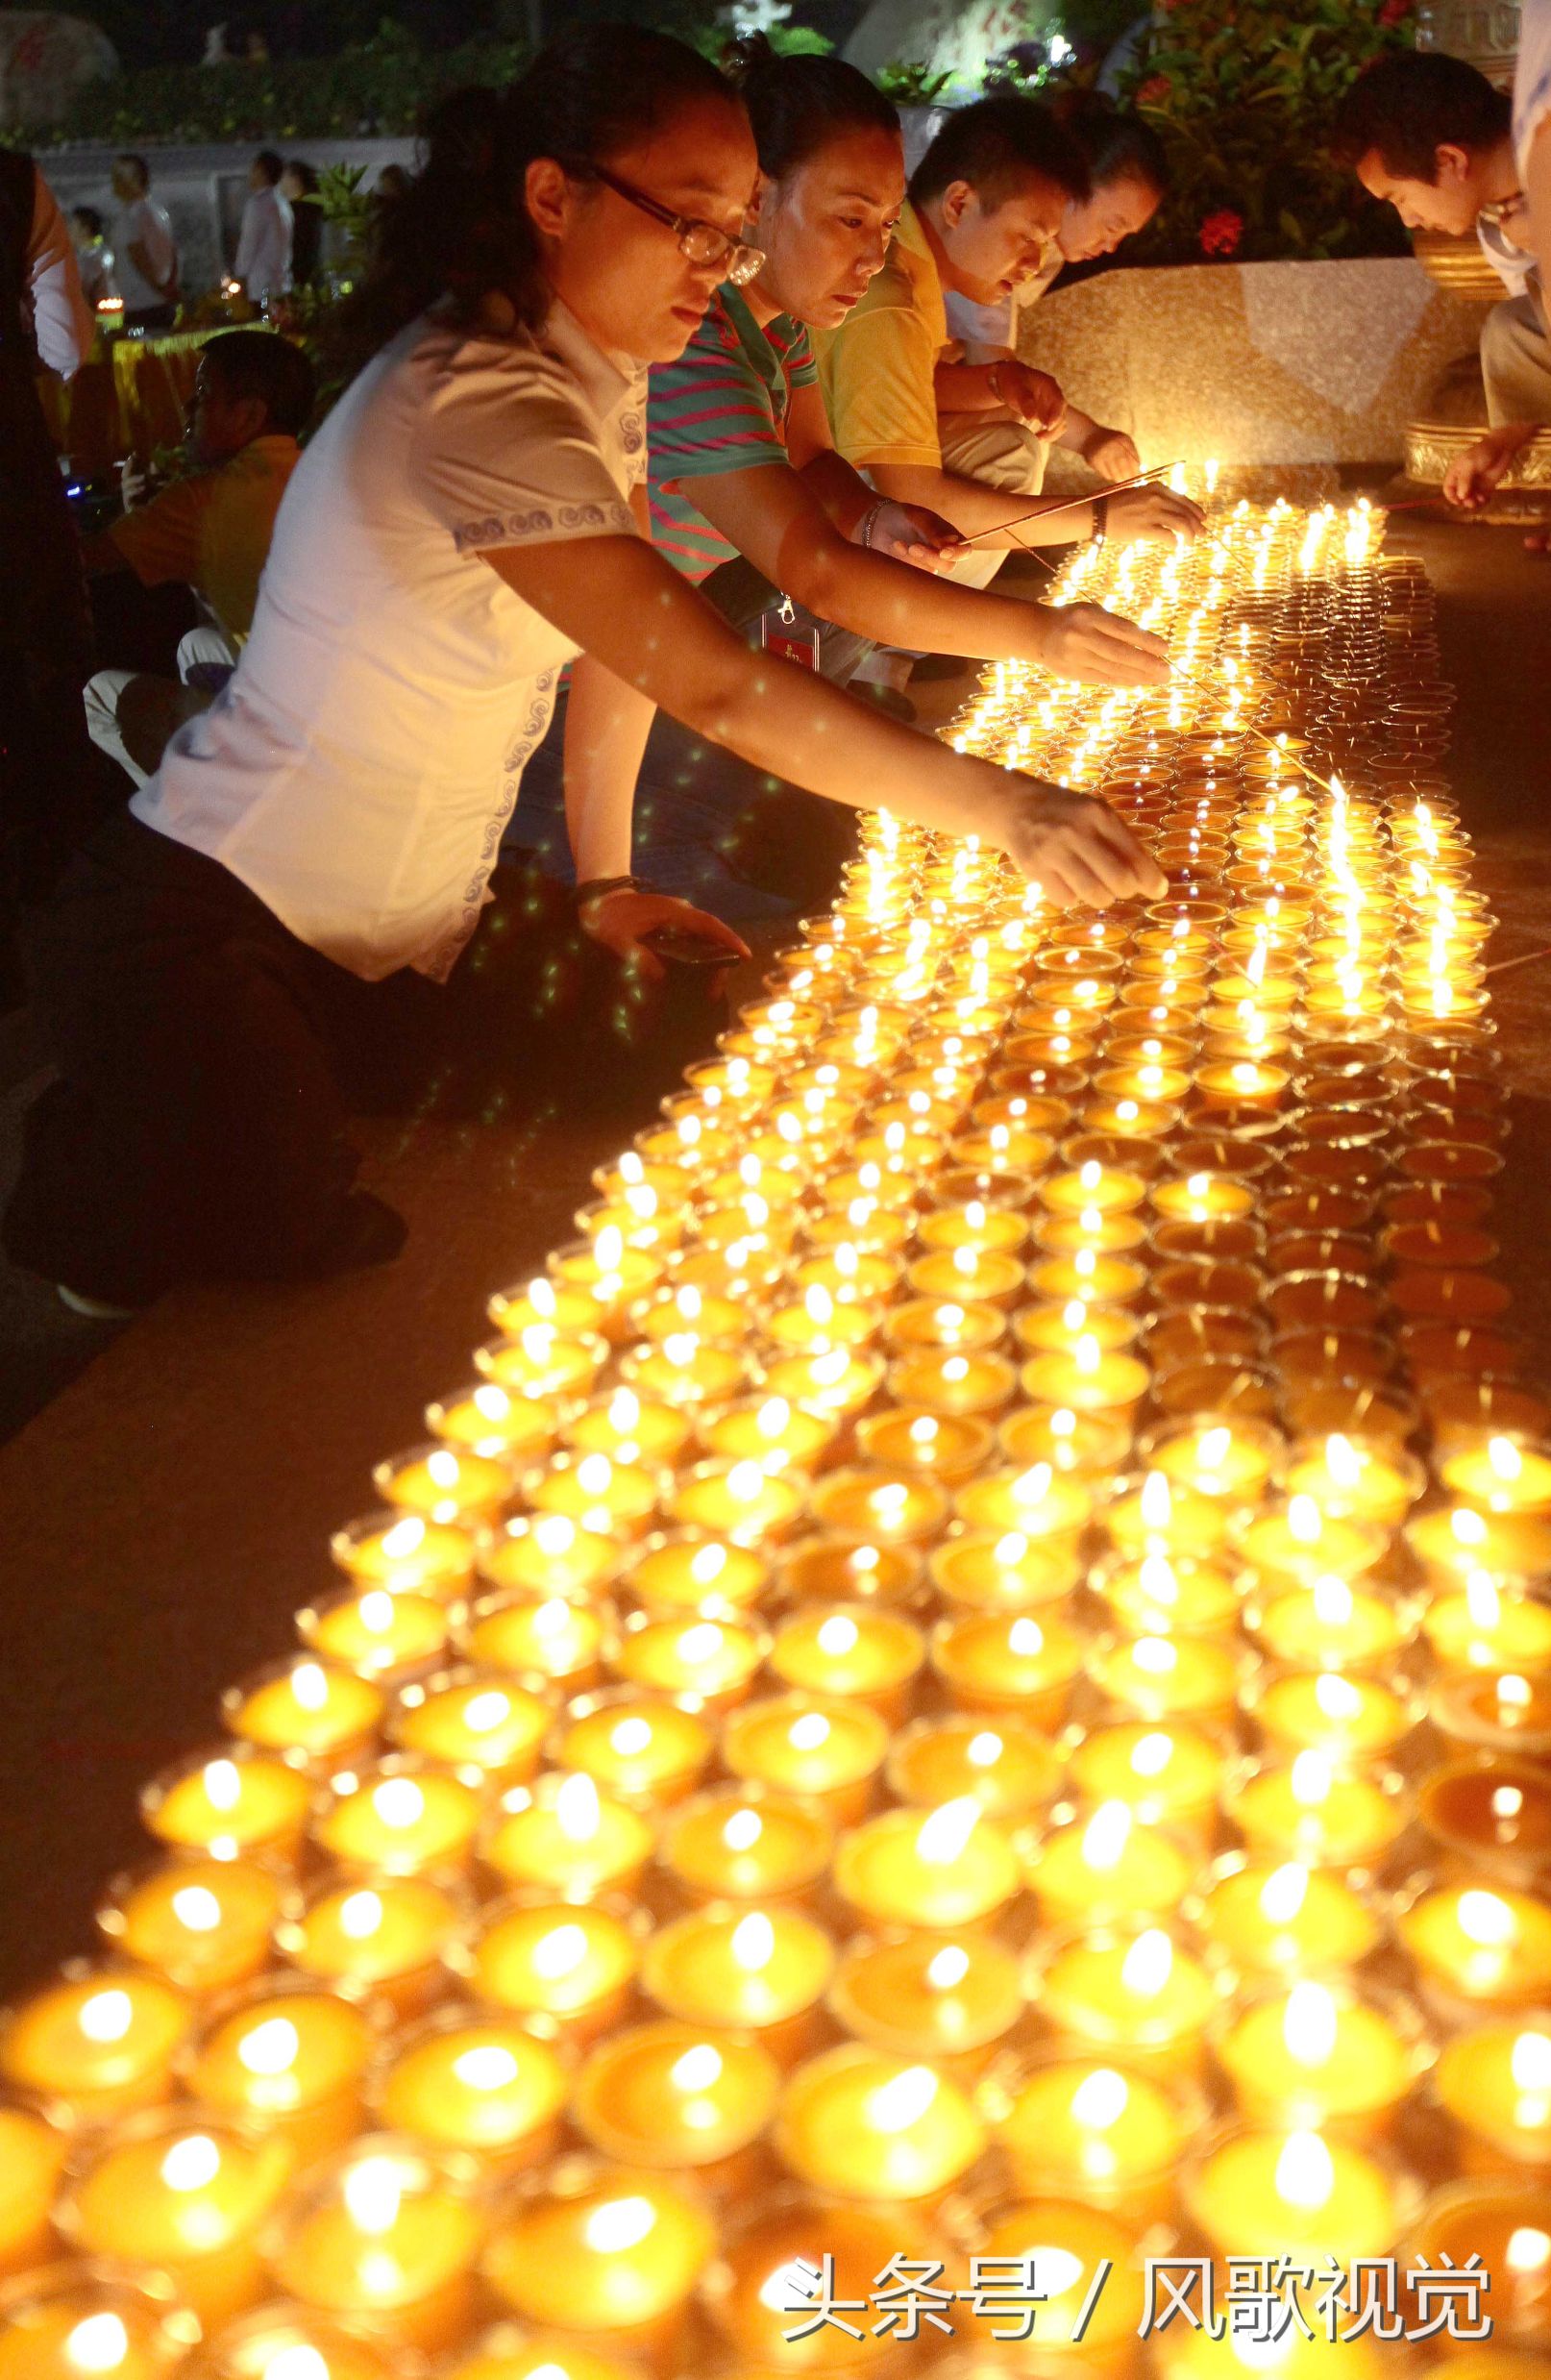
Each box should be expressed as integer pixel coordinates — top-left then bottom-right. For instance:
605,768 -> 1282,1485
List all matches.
340,24 -> 737,364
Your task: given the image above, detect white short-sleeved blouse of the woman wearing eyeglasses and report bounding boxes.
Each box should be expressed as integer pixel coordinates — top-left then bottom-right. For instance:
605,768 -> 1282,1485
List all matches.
131,307 -> 645,980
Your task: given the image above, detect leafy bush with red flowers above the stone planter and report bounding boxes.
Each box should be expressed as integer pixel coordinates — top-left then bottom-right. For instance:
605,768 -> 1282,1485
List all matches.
1120,0 -> 1411,264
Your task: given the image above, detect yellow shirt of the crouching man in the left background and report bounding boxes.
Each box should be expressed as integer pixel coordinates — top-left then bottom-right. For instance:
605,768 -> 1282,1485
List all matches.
107,431 -> 302,645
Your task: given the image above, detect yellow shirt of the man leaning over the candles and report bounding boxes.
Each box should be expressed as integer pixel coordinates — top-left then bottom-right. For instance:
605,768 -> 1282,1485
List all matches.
811,202 -> 956,471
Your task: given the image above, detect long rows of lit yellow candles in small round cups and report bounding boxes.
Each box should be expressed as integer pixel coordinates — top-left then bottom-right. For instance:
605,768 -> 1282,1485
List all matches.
0,502 -> 1551,2380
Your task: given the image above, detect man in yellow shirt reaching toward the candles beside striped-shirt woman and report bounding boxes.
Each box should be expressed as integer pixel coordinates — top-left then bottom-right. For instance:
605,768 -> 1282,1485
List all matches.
819,98 -> 1199,585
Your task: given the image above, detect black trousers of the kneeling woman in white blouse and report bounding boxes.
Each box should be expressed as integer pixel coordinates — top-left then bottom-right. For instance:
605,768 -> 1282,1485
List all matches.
2,814 -> 724,1304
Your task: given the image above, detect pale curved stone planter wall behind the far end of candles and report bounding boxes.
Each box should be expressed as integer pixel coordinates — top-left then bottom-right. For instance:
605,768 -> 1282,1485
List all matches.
1022,257 -> 1480,464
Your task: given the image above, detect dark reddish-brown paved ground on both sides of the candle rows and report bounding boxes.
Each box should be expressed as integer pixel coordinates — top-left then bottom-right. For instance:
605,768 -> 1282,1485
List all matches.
0,516 -> 1551,1992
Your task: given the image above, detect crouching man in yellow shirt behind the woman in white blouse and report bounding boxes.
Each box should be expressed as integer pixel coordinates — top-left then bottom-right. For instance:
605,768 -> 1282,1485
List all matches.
86,331 -> 314,785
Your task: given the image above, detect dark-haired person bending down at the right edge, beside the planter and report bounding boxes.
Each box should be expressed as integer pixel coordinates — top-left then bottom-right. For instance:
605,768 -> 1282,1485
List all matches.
1330,50 -> 1551,507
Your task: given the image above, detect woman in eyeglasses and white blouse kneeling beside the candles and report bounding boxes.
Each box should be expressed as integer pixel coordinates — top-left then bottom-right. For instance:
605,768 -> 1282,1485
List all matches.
7,26 -> 1164,1309
